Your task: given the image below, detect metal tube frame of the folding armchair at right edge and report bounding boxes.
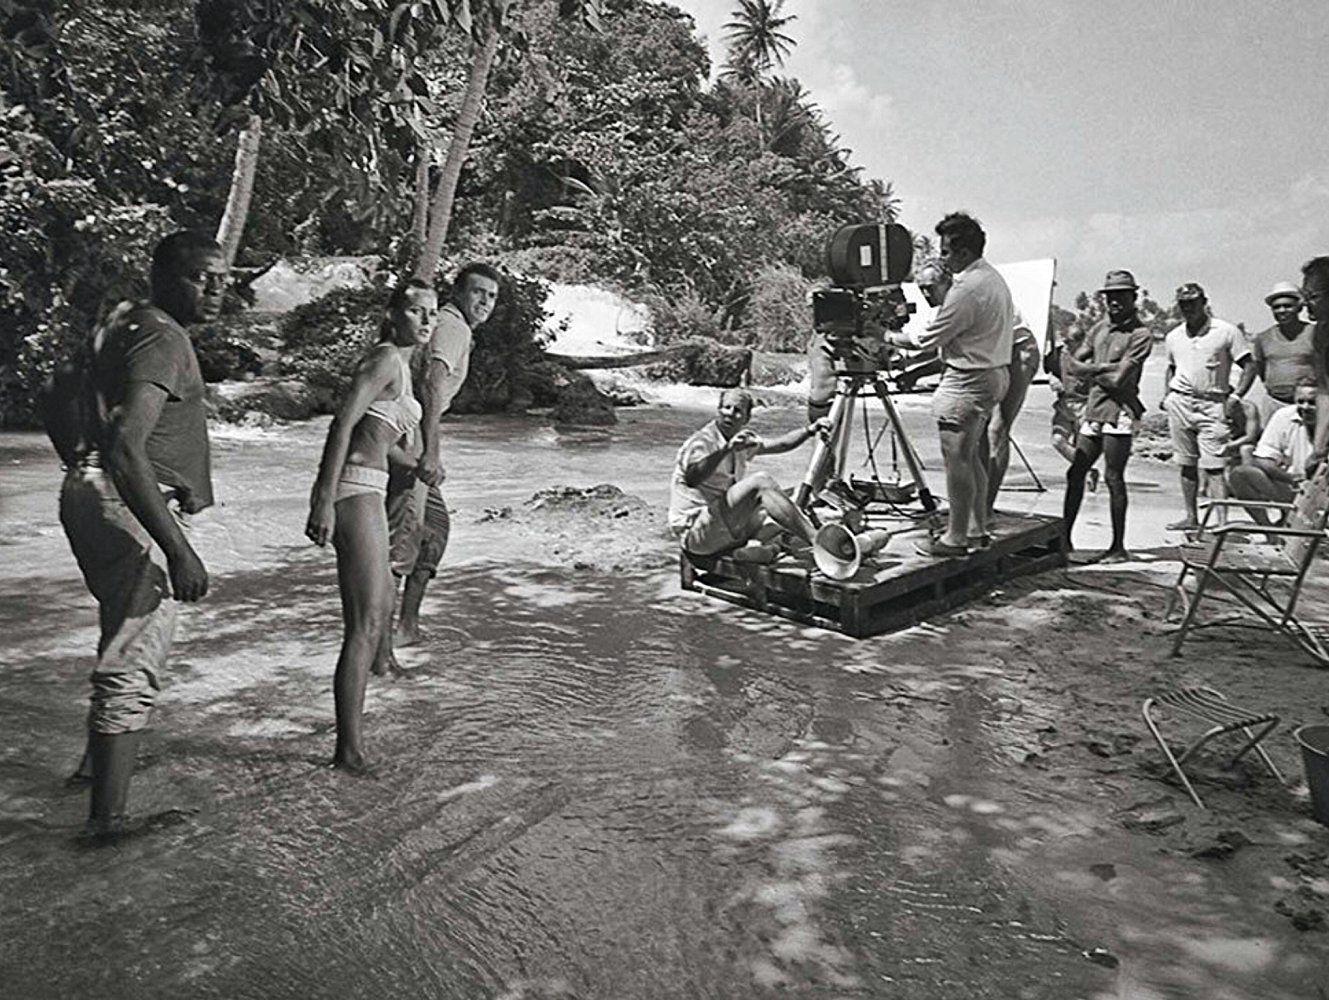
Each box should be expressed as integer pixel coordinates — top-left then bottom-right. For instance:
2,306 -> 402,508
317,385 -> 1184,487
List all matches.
1163,500 -> 1329,666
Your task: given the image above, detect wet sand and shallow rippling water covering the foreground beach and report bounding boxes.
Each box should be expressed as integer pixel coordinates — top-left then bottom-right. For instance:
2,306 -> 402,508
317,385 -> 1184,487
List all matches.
0,388 -> 1329,1000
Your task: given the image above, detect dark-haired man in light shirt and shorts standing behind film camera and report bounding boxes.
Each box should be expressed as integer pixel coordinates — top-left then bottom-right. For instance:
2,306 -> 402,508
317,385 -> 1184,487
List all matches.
886,211 -> 1015,557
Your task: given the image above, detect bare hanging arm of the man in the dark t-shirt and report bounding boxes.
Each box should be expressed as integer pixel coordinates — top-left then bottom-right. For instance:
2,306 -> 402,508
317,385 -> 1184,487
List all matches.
102,382 -> 207,601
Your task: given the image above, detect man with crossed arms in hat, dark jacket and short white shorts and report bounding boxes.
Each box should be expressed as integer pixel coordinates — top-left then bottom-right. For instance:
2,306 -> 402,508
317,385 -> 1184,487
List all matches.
1061,270 -> 1154,563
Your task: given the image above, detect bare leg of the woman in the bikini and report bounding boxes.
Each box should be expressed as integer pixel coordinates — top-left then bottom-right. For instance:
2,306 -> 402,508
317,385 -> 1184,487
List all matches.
332,493 -> 395,774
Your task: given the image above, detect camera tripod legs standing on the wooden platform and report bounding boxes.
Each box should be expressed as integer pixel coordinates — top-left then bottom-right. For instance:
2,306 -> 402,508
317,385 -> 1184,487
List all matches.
793,370 -> 937,516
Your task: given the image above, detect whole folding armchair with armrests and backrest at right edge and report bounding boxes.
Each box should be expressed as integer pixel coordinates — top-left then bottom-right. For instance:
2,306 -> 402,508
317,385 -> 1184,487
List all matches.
1163,472 -> 1329,666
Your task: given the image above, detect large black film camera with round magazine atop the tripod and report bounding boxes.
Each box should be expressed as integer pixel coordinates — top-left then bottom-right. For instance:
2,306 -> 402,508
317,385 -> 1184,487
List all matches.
812,222 -> 916,371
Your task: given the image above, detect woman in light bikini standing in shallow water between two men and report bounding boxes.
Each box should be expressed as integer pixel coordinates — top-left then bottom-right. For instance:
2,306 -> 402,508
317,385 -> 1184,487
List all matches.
304,279 -> 439,774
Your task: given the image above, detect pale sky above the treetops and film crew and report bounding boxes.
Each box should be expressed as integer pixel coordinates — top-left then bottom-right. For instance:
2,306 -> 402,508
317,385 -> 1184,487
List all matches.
670,0 -> 1329,330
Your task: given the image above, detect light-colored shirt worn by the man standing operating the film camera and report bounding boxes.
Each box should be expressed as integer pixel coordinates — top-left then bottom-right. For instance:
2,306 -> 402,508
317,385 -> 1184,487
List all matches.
909,257 -> 1015,370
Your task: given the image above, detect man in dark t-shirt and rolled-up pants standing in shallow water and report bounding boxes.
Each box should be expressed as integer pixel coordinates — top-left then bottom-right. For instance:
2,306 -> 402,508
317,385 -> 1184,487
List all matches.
60,233 -> 226,840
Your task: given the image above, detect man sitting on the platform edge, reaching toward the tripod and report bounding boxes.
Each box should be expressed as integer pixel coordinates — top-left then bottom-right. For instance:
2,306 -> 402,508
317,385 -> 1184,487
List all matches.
668,388 -> 831,561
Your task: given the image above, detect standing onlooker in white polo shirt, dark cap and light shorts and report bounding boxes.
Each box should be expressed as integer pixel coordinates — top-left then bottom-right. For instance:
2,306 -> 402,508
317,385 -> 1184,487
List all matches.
1163,282 -> 1255,531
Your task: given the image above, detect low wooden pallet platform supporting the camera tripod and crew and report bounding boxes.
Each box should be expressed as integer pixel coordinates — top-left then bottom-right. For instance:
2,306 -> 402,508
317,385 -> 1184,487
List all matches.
680,513 -> 1066,638
